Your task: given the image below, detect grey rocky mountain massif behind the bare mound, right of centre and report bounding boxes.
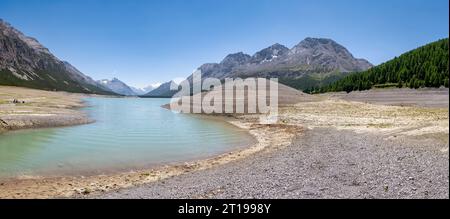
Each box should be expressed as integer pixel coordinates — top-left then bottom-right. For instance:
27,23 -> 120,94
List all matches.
187,37 -> 373,90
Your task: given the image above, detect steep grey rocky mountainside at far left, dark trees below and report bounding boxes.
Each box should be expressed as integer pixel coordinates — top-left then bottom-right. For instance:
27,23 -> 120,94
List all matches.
0,19 -> 113,94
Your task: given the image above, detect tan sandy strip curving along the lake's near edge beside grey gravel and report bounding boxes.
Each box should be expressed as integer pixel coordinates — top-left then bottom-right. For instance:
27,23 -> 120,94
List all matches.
0,117 -> 302,199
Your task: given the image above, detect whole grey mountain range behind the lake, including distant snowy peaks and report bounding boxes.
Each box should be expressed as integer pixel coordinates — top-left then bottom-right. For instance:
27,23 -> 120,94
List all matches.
0,20 -> 373,97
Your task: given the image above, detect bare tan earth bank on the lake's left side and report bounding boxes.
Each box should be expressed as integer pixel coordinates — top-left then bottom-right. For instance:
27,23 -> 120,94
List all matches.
0,86 -> 92,133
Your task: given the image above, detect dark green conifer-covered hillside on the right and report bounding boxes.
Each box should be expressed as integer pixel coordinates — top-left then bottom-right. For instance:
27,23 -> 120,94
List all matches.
305,38 -> 449,93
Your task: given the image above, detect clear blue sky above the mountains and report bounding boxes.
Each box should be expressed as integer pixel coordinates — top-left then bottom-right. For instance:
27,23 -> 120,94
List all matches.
0,0 -> 449,87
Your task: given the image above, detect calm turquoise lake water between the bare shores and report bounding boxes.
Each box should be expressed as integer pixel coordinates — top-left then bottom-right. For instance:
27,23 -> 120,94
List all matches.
0,98 -> 252,178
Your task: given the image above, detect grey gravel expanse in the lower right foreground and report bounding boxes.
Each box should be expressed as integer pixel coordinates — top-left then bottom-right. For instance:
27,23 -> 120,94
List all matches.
95,128 -> 449,199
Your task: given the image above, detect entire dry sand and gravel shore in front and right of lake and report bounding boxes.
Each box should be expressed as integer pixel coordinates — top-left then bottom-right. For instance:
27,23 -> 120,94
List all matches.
0,86 -> 449,198
